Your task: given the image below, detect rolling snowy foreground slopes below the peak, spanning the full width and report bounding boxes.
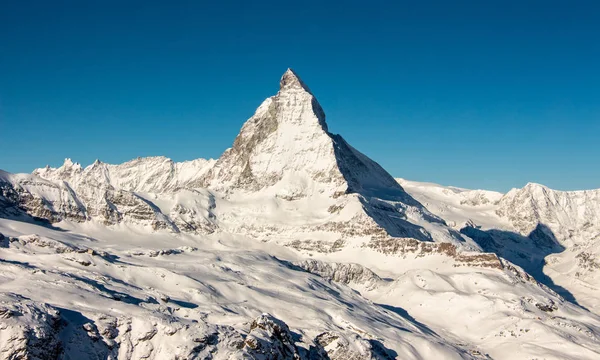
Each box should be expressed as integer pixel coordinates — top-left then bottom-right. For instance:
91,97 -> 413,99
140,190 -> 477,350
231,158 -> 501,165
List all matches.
0,219 -> 600,359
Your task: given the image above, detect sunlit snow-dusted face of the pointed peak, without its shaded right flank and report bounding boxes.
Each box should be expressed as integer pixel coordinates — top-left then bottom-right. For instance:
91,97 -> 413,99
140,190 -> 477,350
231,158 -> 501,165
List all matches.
203,70 -> 346,197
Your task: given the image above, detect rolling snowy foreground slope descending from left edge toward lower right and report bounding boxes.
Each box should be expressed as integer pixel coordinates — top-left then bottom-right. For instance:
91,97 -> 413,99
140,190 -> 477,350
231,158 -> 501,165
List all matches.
0,220 -> 478,359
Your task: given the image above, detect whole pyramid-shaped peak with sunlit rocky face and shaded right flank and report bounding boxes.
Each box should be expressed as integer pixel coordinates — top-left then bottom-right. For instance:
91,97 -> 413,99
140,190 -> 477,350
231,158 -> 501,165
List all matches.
192,69 -> 463,251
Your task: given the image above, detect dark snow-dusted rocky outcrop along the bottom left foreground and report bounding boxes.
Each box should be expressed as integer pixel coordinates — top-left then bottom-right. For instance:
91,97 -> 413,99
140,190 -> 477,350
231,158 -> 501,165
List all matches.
0,300 -> 400,360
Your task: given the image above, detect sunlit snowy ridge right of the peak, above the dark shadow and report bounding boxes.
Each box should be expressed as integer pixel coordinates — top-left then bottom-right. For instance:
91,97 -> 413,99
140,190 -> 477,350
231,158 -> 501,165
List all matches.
396,178 -> 600,241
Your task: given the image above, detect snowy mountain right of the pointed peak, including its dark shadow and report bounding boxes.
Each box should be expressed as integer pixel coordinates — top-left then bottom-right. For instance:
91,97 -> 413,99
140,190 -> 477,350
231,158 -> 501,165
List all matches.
398,179 -> 600,311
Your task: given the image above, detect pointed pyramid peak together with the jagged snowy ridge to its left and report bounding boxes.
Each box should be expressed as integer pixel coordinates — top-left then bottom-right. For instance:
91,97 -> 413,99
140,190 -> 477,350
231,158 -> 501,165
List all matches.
0,69 -> 472,258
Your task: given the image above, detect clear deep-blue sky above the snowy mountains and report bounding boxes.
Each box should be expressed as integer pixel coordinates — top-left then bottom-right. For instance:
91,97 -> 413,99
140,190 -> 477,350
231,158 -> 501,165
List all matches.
0,0 -> 600,191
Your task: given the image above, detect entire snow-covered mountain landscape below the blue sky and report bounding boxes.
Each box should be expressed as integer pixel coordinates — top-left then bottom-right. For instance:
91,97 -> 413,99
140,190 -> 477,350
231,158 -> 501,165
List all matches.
0,70 -> 600,360
